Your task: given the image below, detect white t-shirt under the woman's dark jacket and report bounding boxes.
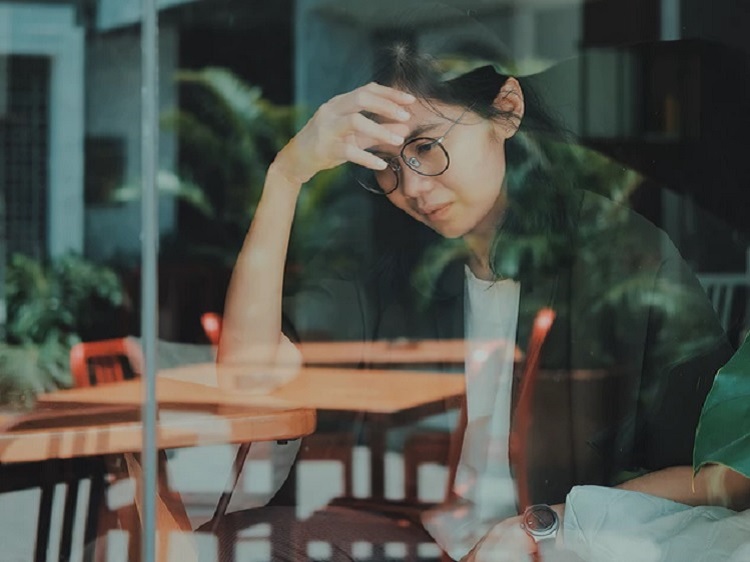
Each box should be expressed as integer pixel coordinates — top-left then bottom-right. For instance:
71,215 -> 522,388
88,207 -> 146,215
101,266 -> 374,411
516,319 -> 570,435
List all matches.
424,267 -> 521,560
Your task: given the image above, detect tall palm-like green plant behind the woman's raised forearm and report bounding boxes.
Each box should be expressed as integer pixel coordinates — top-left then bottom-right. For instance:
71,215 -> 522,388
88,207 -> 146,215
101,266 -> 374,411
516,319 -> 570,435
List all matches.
156,68 -> 352,276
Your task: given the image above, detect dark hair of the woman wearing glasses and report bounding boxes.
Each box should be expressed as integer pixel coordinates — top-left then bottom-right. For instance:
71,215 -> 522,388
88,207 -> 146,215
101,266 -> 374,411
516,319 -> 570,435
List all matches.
375,43 -> 575,288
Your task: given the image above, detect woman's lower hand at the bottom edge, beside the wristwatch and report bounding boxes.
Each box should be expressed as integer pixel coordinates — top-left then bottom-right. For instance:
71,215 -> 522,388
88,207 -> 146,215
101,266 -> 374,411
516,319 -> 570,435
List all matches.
461,504 -> 565,562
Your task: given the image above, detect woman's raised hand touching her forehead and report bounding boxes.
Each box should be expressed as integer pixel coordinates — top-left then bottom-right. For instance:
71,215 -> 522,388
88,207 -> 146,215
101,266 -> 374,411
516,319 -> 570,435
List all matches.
273,82 -> 416,184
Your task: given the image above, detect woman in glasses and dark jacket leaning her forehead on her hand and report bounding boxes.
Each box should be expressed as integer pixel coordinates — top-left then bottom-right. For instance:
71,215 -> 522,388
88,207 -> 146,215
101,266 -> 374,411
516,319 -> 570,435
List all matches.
218,45 -> 745,560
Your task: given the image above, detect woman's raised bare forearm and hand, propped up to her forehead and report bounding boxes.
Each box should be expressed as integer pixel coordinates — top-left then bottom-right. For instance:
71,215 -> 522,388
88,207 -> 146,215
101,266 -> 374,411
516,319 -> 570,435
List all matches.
217,83 -> 415,365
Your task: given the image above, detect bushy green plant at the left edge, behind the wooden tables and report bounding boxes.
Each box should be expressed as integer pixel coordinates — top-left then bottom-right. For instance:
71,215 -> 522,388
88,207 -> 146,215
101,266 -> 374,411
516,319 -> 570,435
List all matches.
0,254 -> 123,405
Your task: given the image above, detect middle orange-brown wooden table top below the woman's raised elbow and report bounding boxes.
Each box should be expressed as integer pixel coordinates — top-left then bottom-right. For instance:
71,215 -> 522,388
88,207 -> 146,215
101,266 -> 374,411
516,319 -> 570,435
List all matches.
45,363 -> 465,414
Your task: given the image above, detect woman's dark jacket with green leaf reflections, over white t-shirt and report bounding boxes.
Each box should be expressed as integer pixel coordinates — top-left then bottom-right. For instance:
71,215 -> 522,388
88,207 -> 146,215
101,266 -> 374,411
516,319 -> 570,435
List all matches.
284,193 -> 732,503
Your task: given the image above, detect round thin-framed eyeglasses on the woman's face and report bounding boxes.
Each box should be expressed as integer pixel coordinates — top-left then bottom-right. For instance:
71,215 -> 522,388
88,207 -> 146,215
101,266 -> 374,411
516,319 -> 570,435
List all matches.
354,109 -> 468,195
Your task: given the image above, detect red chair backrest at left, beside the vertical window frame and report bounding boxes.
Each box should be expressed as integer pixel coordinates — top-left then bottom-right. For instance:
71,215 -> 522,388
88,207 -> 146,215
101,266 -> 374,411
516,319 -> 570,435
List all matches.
70,338 -> 143,387
